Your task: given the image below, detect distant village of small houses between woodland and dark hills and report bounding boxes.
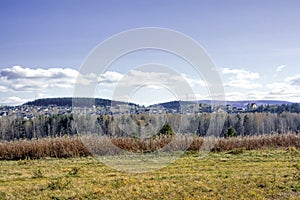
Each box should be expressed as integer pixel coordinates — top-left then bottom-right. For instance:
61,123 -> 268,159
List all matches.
0,97 -> 300,120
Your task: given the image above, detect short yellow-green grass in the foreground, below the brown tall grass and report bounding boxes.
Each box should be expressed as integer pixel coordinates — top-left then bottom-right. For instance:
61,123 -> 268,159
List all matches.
0,148 -> 300,199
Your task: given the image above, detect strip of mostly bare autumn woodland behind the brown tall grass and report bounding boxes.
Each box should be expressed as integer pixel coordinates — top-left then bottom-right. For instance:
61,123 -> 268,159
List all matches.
0,112 -> 300,140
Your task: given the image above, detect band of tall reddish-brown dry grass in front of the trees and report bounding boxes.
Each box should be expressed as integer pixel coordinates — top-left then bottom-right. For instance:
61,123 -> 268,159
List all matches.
0,134 -> 300,160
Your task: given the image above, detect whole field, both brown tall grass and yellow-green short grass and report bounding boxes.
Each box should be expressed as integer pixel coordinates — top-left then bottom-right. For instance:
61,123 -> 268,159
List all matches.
0,134 -> 300,199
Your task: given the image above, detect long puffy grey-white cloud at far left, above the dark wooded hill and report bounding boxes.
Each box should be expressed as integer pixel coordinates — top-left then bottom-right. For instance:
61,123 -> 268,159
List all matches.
0,66 -> 97,92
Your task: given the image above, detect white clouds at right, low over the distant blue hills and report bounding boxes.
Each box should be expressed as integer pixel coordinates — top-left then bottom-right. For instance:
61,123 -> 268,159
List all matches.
222,65 -> 300,102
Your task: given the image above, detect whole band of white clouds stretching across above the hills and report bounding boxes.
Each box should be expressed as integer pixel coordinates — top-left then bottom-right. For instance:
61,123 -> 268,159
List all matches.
0,65 -> 300,105
